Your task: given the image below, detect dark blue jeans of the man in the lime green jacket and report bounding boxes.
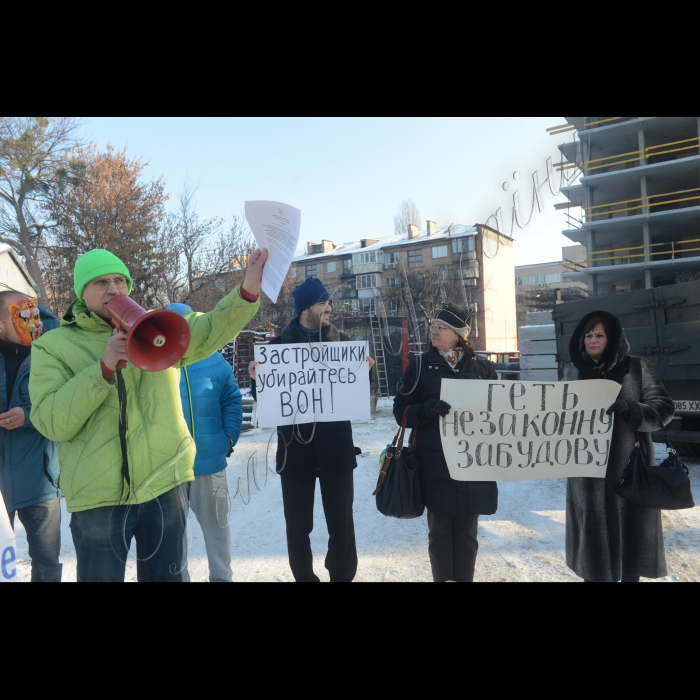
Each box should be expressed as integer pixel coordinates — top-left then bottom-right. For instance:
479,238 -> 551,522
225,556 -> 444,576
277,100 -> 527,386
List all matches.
70,486 -> 188,583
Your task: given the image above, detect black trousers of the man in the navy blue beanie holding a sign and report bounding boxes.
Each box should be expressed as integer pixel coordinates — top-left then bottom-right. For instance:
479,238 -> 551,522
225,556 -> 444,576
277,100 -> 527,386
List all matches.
281,471 -> 357,583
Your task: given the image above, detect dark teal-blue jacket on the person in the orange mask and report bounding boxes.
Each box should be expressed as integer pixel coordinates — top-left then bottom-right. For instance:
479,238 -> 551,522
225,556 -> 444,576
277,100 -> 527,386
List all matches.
0,307 -> 60,512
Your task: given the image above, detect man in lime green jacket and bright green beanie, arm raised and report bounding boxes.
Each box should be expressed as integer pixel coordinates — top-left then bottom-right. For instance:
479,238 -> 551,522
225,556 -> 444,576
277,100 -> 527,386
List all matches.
29,250 -> 267,582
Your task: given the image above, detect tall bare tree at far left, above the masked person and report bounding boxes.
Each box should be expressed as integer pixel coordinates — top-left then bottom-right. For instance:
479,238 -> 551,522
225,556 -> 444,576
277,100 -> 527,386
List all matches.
0,117 -> 80,307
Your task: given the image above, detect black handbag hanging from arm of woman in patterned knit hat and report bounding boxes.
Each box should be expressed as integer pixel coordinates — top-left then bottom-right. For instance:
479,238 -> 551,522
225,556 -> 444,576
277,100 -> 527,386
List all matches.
372,408 -> 425,520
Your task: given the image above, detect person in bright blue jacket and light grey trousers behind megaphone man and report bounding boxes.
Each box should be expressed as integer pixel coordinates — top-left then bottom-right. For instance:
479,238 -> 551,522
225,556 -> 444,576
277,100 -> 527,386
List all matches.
168,304 -> 243,583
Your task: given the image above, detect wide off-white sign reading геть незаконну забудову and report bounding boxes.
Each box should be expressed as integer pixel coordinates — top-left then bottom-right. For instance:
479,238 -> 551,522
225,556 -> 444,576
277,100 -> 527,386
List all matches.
440,379 -> 620,481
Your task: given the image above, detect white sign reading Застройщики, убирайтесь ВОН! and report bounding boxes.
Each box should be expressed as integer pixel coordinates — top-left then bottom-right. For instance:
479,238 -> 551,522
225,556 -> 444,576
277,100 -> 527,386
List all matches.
255,341 -> 371,428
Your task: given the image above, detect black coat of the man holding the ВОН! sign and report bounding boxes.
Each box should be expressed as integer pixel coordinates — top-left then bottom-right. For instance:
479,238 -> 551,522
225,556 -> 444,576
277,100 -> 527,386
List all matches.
252,318 -> 357,479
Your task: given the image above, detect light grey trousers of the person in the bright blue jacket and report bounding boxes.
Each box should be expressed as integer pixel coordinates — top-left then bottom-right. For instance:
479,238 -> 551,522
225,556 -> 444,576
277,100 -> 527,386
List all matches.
182,469 -> 233,583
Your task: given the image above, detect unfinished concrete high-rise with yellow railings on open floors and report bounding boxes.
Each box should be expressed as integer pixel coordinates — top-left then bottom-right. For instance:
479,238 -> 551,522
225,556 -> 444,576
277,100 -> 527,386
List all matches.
555,117 -> 700,294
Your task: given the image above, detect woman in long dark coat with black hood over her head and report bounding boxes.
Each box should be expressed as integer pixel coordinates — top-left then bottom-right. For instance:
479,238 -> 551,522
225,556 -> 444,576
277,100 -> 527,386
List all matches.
563,311 -> 674,583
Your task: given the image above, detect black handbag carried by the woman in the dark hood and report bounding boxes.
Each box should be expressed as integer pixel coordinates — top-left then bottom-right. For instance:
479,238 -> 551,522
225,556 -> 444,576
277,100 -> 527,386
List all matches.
615,404 -> 695,510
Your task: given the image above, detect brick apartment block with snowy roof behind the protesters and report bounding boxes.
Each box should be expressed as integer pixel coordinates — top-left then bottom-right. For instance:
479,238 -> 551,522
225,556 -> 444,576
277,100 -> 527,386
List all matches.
292,221 -> 517,353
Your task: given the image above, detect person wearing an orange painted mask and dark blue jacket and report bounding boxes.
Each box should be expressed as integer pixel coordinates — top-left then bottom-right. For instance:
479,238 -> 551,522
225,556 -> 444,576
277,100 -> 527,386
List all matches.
0,291 -> 63,583
